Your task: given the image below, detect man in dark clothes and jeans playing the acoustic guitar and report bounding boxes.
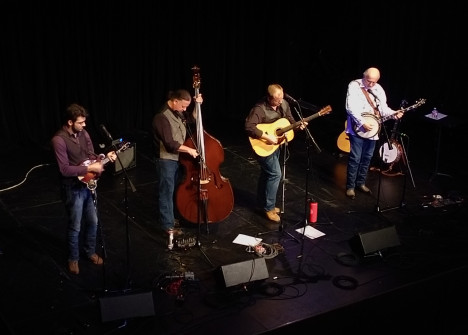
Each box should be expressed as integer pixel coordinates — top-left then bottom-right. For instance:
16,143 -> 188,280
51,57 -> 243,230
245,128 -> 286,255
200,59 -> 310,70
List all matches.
245,84 -> 307,223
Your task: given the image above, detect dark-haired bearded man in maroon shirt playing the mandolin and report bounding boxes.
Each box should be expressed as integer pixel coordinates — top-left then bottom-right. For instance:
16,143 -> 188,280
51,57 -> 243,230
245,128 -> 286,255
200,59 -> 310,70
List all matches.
51,104 -> 117,274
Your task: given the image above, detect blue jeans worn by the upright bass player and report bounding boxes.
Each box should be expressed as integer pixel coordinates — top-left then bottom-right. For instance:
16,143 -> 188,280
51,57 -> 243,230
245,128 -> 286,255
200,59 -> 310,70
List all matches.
158,158 -> 179,230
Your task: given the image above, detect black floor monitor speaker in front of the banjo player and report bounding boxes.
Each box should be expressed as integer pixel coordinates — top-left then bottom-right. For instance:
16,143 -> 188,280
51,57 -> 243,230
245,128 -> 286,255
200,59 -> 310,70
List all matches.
350,226 -> 400,255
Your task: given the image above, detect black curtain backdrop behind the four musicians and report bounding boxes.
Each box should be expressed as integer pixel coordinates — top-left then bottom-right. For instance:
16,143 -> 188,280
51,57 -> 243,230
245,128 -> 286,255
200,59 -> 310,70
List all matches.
0,0 -> 467,152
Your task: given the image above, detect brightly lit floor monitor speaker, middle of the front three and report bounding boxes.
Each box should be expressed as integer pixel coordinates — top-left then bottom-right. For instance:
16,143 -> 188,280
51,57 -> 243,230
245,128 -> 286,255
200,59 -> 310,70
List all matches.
216,258 -> 268,287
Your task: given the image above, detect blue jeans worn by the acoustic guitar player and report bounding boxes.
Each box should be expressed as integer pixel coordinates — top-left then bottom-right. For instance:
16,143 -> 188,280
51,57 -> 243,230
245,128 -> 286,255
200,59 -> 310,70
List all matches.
257,149 -> 281,211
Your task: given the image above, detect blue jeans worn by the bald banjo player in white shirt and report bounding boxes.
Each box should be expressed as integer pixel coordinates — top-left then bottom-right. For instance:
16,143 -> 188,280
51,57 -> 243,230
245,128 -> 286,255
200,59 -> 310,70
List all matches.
346,134 -> 377,189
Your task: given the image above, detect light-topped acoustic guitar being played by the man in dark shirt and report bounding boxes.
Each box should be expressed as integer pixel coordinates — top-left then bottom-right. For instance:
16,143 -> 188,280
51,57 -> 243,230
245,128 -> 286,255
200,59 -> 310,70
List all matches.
249,105 -> 332,157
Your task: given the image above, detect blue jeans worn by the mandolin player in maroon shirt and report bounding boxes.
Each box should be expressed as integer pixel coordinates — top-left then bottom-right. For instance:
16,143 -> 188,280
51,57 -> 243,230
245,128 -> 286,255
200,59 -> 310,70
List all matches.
62,184 -> 98,261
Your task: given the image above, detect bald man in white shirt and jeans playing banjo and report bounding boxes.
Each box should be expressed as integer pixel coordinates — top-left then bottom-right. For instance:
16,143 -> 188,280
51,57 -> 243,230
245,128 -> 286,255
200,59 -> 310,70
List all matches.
346,67 -> 403,199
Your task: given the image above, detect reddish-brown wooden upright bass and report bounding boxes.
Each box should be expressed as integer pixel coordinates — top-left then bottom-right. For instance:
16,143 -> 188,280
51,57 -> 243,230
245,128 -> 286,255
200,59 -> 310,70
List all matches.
176,66 -> 234,224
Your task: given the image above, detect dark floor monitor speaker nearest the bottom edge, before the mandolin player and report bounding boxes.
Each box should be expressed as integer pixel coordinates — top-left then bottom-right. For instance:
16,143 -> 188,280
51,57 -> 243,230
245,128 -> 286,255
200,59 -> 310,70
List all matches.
99,292 -> 154,322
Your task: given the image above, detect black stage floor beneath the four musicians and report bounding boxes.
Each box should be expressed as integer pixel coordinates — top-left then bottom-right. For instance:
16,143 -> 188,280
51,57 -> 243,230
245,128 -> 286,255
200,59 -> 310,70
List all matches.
0,121 -> 468,334
